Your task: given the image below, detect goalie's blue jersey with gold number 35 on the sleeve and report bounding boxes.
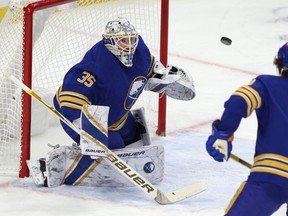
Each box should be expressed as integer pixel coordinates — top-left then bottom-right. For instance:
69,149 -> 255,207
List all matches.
54,36 -> 155,143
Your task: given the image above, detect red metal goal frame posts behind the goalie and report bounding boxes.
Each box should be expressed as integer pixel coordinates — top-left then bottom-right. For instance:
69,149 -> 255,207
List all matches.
19,0 -> 169,178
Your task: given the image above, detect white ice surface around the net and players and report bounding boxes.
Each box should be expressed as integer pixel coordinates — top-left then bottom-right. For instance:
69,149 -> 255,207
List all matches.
0,0 -> 288,216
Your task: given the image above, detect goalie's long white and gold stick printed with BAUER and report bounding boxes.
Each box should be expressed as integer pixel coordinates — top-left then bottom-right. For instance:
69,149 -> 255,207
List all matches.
9,75 -> 206,205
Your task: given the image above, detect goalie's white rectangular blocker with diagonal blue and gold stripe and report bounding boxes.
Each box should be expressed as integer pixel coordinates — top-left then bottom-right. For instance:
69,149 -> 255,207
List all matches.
80,105 -> 109,157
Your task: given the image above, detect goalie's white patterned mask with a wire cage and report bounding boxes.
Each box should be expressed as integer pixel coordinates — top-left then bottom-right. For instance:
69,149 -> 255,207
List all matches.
103,18 -> 139,67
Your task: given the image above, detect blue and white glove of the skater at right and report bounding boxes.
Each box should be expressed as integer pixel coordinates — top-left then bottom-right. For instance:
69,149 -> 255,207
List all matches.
206,120 -> 233,162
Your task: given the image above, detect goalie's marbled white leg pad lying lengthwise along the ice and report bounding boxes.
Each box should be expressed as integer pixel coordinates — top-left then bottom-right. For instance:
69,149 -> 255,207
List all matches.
39,146 -> 164,187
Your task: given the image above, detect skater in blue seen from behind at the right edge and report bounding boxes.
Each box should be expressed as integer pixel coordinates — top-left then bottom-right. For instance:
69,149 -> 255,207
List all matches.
206,43 -> 288,216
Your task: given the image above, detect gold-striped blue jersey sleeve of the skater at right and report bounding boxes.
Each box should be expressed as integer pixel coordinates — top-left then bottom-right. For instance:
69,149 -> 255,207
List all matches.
219,78 -> 265,134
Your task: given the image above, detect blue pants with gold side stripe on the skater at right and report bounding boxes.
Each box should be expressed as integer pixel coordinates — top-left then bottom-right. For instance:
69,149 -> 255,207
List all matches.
225,182 -> 288,216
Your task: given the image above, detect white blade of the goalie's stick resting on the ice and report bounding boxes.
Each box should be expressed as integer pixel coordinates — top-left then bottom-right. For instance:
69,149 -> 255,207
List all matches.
155,182 -> 206,205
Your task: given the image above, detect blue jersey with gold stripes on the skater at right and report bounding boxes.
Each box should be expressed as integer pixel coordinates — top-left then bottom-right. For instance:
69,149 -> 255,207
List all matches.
219,75 -> 288,188
